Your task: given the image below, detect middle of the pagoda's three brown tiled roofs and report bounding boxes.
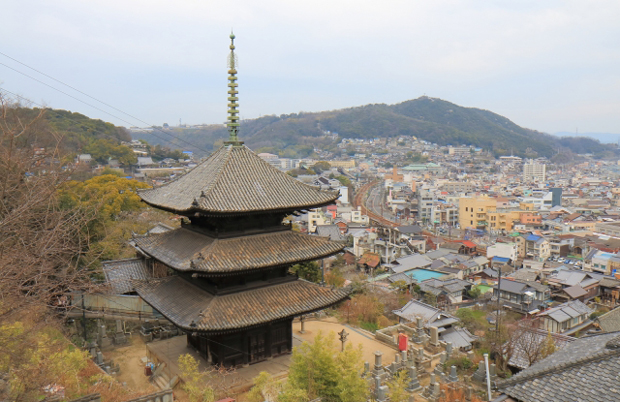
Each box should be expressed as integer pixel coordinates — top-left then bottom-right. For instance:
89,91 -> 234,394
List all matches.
134,228 -> 344,274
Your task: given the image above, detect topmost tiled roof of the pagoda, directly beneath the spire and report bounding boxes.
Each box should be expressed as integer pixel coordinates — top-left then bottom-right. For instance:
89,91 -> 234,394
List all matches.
139,145 -> 339,215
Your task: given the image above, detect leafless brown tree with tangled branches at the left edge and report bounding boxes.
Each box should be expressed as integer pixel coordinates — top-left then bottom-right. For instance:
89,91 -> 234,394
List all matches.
0,97 -> 96,324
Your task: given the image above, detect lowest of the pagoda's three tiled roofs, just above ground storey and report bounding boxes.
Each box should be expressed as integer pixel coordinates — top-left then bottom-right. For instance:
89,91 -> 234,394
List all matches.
132,276 -> 348,333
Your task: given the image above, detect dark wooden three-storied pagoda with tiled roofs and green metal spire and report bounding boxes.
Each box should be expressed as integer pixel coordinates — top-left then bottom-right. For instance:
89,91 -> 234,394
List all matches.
133,35 -> 347,366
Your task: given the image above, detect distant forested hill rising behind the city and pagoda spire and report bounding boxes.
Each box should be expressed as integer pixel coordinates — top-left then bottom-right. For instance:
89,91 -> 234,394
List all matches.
135,96 -> 605,156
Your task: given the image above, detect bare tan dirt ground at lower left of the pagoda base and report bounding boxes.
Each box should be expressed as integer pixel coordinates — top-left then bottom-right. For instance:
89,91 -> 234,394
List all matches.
103,336 -> 159,392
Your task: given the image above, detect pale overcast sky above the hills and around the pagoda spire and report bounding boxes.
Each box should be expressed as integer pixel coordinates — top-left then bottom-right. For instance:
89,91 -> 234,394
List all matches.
0,0 -> 620,133
